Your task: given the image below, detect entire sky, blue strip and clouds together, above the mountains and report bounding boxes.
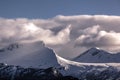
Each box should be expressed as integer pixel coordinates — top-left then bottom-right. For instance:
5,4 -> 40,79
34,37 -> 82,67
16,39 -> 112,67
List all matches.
0,0 -> 120,59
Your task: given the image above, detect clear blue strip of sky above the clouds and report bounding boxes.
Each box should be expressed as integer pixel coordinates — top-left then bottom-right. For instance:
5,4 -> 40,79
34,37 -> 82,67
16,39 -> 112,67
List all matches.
0,0 -> 120,19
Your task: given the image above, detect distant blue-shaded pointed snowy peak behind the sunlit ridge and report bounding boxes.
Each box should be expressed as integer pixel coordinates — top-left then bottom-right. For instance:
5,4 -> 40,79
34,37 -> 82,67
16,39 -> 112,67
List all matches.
74,48 -> 120,63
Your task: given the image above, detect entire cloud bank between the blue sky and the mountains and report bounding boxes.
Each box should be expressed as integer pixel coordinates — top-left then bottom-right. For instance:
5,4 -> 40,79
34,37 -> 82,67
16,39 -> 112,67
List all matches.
0,15 -> 120,56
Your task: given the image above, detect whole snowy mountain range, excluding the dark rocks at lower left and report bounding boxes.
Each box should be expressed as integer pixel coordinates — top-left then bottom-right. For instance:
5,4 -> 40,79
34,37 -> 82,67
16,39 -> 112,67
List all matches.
0,41 -> 120,80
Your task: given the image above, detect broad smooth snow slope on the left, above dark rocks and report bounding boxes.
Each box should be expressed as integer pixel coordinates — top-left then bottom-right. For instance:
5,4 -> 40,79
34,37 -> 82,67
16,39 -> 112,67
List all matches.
0,41 -> 59,68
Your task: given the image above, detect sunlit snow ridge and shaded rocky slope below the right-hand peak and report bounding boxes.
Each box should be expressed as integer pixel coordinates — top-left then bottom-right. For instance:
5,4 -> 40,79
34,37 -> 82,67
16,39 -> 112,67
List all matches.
57,55 -> 120,80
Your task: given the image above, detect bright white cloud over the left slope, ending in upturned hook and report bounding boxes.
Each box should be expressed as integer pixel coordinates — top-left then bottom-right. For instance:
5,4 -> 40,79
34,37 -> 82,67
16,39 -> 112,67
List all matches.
0,19 -> 71,46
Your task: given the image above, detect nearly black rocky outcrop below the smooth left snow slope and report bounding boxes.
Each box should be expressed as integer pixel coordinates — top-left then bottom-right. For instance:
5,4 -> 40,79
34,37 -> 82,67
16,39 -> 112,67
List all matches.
0,63 -> 78,80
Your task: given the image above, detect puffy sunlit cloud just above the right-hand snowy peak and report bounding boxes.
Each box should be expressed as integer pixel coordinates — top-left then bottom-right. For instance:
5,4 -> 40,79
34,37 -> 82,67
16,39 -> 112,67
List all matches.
75,25 -> 120,49
